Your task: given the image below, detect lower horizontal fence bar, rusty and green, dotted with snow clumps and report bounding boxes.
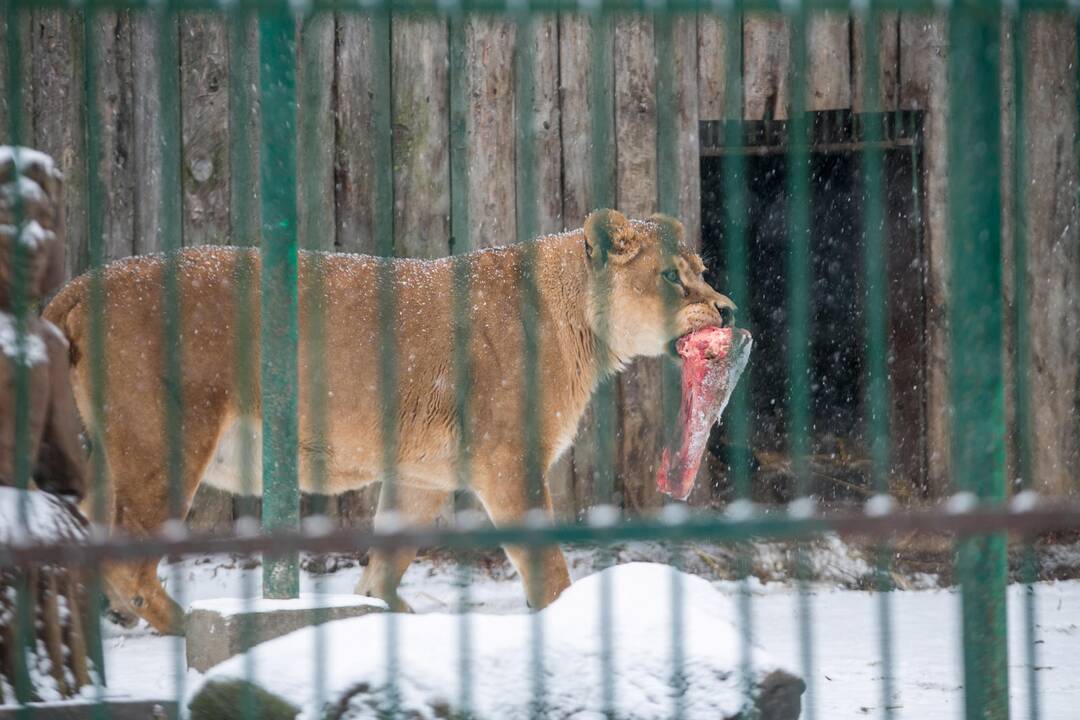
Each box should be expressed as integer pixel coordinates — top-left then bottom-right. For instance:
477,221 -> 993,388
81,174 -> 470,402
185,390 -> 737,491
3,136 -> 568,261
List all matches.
6,505 -> 1080,567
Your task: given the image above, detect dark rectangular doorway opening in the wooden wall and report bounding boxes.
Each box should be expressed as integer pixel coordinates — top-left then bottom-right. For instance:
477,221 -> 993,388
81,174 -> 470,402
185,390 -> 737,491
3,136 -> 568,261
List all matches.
701,112 -> 927,501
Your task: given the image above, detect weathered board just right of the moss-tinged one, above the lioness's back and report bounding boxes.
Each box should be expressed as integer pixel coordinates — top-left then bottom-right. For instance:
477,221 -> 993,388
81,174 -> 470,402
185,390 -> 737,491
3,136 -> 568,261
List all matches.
465,17 -> 516,247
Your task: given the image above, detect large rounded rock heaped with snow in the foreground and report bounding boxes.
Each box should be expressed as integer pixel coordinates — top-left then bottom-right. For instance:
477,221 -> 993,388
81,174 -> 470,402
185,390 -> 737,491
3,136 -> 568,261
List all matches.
188,562 -> 804,720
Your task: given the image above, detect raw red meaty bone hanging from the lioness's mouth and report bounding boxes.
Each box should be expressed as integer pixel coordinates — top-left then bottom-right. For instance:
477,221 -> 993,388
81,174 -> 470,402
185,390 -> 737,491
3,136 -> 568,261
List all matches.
657,327 -> 753,500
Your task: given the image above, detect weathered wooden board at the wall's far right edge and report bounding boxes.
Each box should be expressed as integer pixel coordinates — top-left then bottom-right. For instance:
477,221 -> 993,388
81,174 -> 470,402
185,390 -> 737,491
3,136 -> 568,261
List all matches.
1022,14 -> 1080,497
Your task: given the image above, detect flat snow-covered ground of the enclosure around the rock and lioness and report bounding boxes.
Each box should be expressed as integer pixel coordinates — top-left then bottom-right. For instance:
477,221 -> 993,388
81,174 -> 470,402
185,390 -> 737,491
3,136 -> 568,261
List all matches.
95,540 -> 1080,719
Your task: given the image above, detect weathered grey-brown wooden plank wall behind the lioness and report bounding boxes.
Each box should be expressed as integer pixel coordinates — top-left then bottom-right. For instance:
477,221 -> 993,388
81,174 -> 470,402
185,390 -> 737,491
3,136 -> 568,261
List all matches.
0,10 -> 1080,528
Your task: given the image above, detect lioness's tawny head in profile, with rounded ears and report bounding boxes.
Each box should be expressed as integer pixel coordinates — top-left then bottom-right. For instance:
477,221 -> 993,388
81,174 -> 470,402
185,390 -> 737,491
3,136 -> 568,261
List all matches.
584,209 -> 735,362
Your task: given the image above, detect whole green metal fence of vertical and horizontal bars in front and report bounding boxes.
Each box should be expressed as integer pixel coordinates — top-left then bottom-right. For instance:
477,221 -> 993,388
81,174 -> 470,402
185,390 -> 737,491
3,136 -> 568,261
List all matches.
0,0 -> 1080,719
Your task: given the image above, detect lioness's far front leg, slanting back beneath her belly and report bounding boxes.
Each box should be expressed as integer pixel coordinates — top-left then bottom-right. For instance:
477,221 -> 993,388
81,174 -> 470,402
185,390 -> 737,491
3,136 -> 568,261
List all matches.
356,485 -> 450,612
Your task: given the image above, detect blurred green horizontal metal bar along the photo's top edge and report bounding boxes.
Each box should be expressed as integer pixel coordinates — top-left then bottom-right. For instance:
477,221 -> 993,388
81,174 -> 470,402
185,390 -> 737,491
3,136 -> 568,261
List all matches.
4,0 -> 1074,15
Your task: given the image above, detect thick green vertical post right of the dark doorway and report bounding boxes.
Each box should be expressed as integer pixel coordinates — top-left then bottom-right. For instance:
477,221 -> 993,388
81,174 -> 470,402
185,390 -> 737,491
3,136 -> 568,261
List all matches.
948,0 -> 1009,720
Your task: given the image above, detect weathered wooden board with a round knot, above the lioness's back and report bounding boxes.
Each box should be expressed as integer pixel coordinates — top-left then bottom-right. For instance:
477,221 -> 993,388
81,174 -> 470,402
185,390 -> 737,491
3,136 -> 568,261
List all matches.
180,13 -> 229,245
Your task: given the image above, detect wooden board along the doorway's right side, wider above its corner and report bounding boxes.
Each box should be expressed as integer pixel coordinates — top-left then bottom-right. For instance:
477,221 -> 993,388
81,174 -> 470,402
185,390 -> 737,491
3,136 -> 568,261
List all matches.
900,14 -> 950,497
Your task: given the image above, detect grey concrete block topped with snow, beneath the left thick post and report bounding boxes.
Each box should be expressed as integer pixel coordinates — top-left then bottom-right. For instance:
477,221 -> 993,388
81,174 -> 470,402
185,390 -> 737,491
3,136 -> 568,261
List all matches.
186,595 -> 387,673
